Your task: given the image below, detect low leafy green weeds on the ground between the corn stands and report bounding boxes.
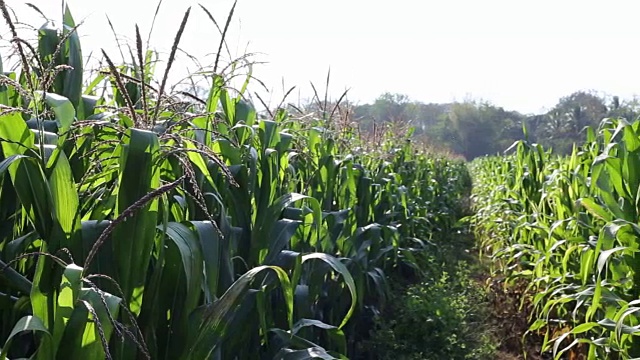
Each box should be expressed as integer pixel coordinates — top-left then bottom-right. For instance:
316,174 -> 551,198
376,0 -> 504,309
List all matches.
360,204 -> 500,360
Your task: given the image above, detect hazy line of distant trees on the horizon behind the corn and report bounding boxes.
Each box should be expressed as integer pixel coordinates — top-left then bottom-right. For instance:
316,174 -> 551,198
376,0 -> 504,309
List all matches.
352,91 -> 640,160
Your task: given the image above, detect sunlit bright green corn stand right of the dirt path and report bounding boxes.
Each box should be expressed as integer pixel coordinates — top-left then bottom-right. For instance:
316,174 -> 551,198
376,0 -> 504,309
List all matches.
471,119 -> 640,359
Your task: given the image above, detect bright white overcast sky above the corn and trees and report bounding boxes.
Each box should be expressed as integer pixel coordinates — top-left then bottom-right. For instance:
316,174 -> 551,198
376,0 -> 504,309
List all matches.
10,0 -> 640,113
